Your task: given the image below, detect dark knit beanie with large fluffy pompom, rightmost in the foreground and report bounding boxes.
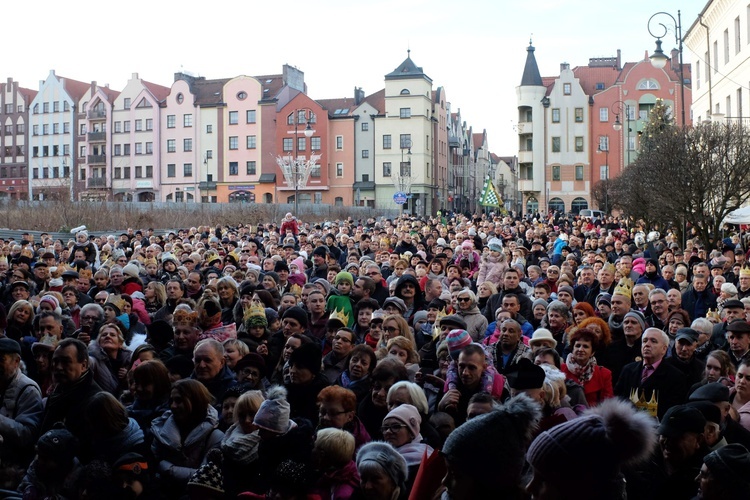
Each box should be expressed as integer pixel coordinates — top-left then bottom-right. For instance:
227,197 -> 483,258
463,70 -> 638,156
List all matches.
526,399 -> 657,488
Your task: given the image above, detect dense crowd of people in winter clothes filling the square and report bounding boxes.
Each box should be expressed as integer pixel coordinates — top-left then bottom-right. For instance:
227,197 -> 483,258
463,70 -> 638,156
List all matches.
0,210 -> 750,500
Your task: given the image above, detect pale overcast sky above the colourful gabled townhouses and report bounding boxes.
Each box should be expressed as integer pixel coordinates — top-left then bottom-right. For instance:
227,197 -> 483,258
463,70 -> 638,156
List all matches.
0,0 -> 707,156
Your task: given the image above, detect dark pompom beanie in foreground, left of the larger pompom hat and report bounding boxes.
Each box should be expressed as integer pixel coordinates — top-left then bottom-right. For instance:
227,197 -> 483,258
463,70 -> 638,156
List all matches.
442,394 -> 541,488
